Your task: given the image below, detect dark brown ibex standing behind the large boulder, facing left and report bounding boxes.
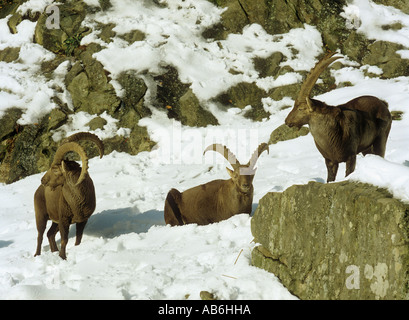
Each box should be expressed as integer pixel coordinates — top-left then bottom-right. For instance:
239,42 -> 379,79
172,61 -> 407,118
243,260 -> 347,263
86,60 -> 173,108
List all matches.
285,53 -> 392,182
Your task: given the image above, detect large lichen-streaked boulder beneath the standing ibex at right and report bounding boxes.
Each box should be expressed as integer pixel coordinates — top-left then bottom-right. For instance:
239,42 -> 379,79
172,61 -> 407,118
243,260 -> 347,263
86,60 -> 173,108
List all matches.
251,181 -> 409,299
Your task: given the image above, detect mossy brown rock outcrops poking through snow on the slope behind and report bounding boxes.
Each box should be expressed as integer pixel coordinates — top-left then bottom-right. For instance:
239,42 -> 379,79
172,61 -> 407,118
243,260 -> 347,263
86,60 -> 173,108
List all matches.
0,0 -> 409,183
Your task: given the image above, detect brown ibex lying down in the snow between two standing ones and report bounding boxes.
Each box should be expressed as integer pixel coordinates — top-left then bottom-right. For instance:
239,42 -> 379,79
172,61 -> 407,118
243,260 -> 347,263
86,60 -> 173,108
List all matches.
165,143 -> 268,226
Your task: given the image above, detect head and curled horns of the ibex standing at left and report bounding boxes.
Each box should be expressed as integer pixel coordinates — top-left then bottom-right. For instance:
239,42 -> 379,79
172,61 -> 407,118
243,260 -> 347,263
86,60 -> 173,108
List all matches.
41,132 -> 104,189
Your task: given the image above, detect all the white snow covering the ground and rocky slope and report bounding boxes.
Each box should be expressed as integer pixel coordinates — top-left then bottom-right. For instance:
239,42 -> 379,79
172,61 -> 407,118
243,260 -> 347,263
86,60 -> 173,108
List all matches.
0,0 -> 409,299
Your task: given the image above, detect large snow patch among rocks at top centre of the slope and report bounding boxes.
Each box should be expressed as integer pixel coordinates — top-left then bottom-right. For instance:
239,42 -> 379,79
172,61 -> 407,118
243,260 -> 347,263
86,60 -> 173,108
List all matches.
88,0 -> 322,100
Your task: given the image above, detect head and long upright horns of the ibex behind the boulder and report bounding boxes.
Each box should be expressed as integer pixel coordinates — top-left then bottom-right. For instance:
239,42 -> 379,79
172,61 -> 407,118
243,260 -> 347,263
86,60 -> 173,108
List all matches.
285,52 -> 342,128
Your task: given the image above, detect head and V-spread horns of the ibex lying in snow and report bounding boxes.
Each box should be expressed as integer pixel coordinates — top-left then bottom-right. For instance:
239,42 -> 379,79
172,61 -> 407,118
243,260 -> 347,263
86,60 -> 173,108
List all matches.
203,143 -> 268,193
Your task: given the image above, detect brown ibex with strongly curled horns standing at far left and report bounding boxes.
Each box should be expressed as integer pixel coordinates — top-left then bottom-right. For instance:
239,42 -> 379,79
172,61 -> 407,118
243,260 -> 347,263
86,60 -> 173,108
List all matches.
34,132 -> 104,259
